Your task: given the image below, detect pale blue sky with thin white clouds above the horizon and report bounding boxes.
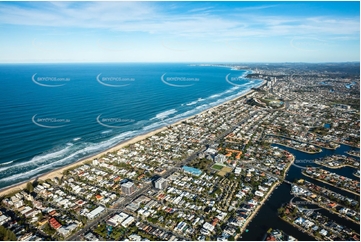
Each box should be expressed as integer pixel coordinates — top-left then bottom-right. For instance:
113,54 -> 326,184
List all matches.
0,1 -> 360,63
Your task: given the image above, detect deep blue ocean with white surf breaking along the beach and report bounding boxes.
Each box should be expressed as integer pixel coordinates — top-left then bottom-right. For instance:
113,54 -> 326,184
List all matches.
0,63 -> 262,188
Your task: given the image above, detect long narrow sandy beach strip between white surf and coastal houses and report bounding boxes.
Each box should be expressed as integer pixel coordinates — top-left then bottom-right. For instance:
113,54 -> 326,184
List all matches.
0,80 -> 267,197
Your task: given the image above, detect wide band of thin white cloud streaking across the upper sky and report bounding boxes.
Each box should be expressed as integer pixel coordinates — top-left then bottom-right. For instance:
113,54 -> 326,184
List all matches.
0,2 -> 359,38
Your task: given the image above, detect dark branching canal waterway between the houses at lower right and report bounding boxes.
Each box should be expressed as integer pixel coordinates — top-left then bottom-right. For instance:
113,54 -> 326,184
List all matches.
238,144 -> 360,241
